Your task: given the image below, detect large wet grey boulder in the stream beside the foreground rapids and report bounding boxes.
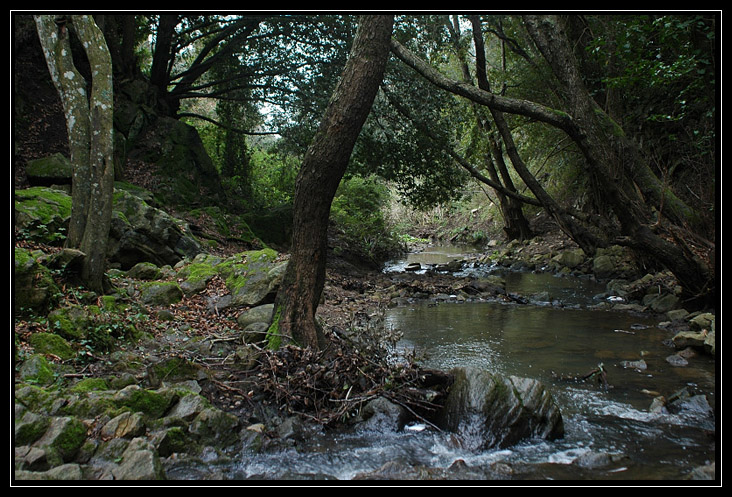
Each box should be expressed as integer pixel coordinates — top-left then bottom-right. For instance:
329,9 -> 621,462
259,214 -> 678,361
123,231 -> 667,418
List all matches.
438,368 -> 564,450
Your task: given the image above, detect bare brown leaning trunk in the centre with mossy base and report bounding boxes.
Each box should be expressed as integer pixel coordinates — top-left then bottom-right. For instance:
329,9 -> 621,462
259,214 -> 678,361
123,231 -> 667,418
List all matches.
269,16 -> 393,348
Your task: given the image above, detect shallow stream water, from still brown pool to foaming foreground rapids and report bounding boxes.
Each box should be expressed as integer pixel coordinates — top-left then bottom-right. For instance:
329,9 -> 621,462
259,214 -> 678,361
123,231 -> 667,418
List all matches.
217,247 -> 715,481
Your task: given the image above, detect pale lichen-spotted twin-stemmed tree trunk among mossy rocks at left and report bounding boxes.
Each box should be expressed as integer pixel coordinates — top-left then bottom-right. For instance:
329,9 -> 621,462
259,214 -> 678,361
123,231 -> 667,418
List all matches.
35,15 -> 114,293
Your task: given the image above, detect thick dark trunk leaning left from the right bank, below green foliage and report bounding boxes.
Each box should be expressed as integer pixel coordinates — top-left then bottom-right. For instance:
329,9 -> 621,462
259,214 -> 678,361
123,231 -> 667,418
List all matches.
524,16 -> 715,304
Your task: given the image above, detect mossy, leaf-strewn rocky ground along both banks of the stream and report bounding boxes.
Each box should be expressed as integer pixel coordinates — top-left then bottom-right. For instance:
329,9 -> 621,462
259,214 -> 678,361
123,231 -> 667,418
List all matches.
13,183 -> 717,484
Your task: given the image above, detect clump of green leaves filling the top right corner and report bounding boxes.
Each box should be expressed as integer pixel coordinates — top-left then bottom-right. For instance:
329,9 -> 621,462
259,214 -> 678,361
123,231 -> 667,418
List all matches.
586,14 -> 716,152
